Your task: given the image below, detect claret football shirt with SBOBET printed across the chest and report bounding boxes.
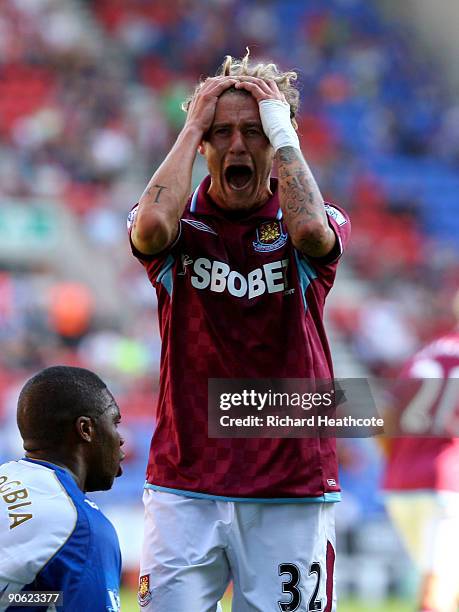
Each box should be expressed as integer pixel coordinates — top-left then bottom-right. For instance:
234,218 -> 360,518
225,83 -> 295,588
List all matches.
130,177 -> 350,502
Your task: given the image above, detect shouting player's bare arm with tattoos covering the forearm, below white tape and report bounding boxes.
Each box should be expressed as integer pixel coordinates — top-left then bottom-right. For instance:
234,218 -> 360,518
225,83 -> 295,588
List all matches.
236,76 -> 336,257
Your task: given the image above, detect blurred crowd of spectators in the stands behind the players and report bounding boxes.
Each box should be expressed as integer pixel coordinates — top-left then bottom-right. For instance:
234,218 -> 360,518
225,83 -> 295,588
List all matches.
0,0 -> 459,478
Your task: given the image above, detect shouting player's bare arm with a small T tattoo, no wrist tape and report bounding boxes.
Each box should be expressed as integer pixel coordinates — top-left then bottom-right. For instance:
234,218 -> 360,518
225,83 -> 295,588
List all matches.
131,77 -> 235,255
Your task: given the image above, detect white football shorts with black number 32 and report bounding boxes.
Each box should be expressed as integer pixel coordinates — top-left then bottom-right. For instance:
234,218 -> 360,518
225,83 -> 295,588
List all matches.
139,489 -> 336,612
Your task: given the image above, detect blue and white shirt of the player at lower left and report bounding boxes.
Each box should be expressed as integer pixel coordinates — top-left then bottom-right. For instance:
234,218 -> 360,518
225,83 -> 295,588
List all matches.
0,459 -> 121,612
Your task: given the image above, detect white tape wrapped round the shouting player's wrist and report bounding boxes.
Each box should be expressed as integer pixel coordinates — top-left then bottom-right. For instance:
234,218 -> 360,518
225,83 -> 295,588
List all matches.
258,100 -> 300,152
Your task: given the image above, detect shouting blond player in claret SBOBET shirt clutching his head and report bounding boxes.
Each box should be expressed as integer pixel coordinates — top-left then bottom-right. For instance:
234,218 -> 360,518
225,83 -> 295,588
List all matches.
128,54 -> 350,612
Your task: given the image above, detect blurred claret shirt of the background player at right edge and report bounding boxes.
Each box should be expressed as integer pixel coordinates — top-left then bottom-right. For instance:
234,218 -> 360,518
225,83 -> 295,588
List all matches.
383,332 -> 459,492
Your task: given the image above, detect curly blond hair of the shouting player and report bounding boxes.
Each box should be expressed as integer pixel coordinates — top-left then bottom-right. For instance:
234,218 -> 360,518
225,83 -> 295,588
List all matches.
182,48 -> 300,130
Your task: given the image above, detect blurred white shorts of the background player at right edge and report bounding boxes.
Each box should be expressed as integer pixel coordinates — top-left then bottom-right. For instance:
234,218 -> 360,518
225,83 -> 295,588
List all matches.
384,491 -> 459,584
